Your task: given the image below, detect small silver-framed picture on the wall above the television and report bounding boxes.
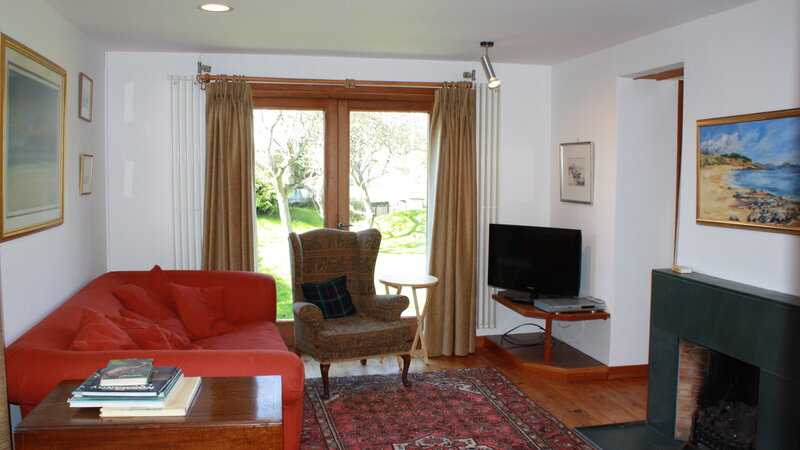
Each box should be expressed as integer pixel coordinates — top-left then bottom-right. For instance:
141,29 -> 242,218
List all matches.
561,142 -> 594,205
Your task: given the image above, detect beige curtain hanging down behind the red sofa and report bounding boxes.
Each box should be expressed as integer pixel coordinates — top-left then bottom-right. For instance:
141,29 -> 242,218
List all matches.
203,81 -> 255,271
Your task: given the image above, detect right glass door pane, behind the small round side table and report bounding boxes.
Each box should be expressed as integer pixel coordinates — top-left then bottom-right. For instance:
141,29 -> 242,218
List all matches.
349,111 -> 428,314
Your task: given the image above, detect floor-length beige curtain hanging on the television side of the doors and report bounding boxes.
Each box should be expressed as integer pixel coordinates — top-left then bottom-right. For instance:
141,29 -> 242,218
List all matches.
425,84 -> 478,356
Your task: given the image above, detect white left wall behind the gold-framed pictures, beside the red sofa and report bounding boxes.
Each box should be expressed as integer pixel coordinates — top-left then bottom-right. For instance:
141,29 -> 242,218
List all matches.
0,0 -> 106,344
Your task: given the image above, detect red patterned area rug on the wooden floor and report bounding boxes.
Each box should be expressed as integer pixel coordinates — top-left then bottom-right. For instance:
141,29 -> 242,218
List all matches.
300,368 -> 594,450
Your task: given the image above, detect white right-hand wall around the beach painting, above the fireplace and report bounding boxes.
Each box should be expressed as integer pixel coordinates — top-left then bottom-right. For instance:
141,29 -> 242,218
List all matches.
550,0 -> 800,366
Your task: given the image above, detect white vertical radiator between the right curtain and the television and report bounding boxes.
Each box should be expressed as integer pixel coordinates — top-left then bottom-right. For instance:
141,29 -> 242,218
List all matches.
475,84 -> 500,329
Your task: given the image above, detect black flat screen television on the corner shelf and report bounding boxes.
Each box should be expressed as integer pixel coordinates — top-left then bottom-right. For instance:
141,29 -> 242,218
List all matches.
488,223 -> 583,298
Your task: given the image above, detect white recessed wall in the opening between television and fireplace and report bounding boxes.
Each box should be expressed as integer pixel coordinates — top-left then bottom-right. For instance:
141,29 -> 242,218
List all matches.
616,78 -> 678,366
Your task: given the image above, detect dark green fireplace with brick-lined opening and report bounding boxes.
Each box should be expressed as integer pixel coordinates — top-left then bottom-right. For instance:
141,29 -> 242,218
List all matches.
647,270 -> 800,449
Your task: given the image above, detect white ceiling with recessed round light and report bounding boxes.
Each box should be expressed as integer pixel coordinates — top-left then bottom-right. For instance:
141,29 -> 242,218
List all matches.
47,0 -> 752,65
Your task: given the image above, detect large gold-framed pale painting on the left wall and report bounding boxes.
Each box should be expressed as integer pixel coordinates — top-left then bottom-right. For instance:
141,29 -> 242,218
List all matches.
0,34 -> 67,240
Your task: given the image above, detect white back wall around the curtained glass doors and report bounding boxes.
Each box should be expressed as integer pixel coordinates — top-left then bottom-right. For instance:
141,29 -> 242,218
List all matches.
107,52 -> 550,334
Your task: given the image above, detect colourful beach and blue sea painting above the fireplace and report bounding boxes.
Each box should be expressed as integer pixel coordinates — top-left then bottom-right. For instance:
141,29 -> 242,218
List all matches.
697,108 -> 800,234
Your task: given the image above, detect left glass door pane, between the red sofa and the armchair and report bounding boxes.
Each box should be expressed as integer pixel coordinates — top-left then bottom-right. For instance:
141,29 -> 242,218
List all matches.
253,109 -> 325,319
